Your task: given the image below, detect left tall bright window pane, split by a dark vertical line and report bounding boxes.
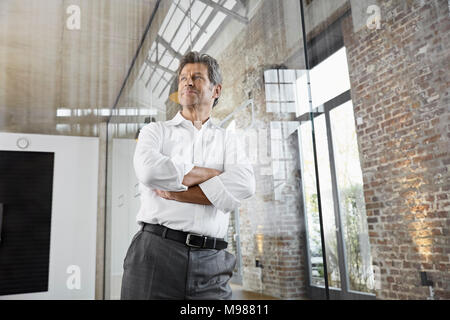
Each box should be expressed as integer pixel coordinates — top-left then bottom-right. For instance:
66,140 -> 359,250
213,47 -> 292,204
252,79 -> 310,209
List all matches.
299,119 -> 341,288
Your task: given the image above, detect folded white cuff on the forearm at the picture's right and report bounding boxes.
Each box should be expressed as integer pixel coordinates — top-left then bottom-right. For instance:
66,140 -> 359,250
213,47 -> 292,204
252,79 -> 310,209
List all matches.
198,176 -> 241,212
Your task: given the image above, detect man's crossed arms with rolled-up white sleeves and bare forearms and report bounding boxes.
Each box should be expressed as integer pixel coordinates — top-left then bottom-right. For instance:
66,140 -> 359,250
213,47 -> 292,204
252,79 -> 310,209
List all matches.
133,123 -> 255,212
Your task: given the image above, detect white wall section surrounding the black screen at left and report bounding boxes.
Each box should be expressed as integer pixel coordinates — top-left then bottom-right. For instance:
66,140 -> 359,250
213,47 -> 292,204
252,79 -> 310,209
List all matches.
0,132 -> 99,300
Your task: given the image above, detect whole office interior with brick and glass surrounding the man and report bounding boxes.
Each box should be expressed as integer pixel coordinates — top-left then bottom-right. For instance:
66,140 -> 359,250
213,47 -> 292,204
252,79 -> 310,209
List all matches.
0,0 -> 450,300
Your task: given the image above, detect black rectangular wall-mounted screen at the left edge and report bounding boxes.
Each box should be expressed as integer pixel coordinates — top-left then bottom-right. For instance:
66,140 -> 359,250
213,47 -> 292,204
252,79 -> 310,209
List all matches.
0,151 -> 55,295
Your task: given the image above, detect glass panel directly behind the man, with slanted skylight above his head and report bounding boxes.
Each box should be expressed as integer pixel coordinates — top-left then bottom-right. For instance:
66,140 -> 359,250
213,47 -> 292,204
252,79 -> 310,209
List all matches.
106,0 -> 314,299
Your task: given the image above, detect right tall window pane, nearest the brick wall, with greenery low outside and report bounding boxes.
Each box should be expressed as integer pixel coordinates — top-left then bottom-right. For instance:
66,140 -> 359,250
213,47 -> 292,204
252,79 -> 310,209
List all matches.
330,101 -> 374,292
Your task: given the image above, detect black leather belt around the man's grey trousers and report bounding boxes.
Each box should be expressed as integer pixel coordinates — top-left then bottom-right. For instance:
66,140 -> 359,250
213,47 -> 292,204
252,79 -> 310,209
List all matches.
142,223 -> 228,250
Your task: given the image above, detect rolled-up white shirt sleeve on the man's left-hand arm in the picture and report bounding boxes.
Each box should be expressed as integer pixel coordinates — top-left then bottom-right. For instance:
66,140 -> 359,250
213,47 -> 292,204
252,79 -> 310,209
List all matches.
133,123 -> 194,191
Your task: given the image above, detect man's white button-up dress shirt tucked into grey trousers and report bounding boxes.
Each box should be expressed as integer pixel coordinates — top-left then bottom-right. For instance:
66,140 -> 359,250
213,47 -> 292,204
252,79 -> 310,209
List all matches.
133,112 -> 255,238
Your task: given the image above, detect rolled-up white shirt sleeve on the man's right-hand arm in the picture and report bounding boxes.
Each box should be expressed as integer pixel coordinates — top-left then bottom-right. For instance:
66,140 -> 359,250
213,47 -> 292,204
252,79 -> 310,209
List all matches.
199,130 -> 255,212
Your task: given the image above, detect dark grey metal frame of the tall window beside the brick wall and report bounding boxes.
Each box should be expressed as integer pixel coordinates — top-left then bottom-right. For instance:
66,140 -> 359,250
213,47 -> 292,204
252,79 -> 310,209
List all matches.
297,0 -> 376,300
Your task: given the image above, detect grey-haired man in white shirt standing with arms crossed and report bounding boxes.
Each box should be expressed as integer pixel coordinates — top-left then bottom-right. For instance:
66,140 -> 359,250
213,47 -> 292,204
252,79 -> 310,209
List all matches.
121,52 -> 255,300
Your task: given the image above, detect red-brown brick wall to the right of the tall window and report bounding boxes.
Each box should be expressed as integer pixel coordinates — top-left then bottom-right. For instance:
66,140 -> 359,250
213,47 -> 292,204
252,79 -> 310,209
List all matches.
343,0 -> 450,299
